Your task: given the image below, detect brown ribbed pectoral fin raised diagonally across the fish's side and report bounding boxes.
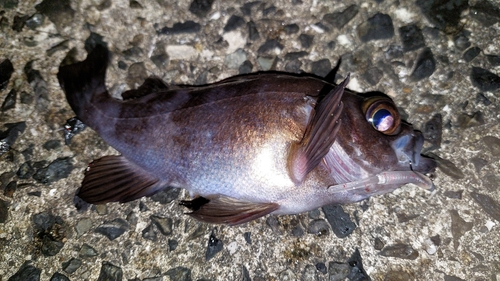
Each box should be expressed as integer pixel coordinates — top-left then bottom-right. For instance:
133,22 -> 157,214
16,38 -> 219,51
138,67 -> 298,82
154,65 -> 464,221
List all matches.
288,75 -> 349,184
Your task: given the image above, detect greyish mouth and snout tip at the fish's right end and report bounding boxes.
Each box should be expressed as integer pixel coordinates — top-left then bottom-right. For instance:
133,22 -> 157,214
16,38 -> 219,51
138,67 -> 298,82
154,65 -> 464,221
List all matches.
392,131 -> 437,174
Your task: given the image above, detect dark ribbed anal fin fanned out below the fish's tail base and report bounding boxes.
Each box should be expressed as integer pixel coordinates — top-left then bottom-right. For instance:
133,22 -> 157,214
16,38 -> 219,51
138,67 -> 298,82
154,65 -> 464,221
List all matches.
77,155 -> 163,204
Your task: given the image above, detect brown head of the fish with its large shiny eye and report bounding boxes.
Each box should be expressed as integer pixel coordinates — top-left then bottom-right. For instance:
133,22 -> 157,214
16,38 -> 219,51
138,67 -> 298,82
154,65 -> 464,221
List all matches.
336,91 -> 436,176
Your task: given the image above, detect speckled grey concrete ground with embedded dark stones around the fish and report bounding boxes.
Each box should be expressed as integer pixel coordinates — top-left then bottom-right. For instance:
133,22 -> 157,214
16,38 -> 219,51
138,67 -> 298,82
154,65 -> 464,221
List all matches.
0,0 -> 500,280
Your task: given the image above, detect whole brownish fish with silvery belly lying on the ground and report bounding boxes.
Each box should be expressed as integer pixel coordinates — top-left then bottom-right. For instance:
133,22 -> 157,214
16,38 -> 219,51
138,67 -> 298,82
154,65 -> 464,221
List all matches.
57,45 -> 436,225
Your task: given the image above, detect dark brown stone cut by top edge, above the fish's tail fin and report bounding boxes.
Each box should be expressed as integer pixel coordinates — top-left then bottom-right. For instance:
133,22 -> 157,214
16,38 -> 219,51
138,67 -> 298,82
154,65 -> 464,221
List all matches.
35,0 -> 75,29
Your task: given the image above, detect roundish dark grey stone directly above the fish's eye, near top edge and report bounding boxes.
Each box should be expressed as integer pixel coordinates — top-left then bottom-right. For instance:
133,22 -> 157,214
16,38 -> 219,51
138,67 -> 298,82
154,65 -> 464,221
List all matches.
357,13 -> 394,42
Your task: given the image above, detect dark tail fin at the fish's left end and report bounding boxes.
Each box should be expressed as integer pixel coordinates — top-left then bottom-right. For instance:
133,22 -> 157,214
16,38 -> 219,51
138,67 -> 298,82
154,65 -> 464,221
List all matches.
57,45 -> 109,121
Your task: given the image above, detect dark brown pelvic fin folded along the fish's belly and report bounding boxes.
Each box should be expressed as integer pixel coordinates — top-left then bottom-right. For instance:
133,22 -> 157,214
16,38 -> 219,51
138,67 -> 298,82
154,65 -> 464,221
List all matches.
181,196 -> 279,225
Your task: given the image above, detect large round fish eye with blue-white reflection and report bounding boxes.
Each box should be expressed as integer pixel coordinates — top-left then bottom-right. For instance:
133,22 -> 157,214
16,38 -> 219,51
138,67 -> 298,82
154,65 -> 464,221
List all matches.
363,97 -> 401,135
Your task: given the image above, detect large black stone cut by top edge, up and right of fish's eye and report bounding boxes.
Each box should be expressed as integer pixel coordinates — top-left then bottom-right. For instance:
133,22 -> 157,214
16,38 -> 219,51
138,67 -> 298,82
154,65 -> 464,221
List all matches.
416,0 -> 469,32
